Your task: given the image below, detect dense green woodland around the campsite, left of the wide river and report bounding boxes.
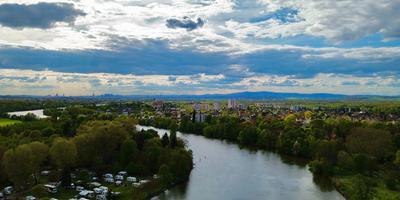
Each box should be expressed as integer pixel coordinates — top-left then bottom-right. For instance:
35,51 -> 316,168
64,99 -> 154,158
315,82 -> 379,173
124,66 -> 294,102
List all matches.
0,106 -> 193,199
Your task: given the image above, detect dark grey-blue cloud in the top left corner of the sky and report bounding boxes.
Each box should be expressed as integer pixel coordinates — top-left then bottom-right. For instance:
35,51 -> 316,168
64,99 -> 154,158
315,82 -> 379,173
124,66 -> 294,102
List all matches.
0,3 -> 85,29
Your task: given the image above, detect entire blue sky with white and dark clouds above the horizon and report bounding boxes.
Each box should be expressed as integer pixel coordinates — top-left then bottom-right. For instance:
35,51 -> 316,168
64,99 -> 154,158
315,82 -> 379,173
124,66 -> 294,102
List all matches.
0,0 -> 400,96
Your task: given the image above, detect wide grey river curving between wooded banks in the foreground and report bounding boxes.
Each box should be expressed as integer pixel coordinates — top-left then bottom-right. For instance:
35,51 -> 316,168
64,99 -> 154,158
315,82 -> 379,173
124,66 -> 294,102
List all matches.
138,126 -> 344,200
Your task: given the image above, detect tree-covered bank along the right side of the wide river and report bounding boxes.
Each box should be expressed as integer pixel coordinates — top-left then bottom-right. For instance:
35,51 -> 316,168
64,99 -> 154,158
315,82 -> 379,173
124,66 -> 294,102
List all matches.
138,115 -> 400,199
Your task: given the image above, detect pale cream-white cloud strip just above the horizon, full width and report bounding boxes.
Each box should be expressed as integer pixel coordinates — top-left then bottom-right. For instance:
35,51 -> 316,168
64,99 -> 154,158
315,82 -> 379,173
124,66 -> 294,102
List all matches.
0,66 -> 400,95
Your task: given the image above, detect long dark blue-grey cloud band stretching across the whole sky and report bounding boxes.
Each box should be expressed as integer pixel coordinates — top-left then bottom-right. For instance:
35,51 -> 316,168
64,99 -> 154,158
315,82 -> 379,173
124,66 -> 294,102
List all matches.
0,39 -> 400,79
